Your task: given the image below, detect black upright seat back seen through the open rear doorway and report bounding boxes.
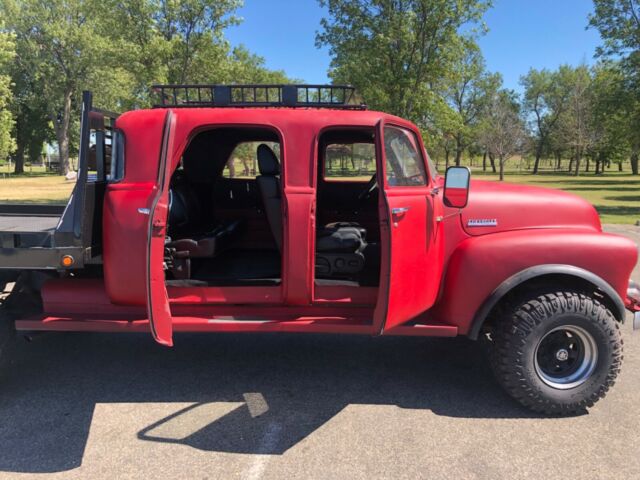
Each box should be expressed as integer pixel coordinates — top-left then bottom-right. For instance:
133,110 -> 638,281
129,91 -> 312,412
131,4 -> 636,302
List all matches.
256,143 -> 282,252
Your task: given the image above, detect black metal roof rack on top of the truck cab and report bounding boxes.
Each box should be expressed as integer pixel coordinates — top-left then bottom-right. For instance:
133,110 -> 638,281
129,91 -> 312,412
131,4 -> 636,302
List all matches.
151,84 -> 367,110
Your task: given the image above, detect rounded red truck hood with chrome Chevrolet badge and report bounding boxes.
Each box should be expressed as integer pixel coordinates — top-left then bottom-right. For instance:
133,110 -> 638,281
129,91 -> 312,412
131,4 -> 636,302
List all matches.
461,180 -> 602,235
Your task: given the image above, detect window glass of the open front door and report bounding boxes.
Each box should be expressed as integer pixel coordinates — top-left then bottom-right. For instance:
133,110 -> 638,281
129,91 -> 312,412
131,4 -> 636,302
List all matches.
384,126 -> 427,187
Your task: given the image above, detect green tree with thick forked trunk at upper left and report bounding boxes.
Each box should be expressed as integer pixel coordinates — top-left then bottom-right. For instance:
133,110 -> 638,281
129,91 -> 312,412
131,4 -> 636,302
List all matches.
2,0 -> 131,173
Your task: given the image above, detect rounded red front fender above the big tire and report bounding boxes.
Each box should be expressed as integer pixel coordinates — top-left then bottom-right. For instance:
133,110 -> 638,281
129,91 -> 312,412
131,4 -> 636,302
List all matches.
429,229 -> 638,336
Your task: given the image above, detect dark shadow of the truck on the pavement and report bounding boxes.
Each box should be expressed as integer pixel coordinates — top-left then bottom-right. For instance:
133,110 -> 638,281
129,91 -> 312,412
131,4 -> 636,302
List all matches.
0,326 -> 535,472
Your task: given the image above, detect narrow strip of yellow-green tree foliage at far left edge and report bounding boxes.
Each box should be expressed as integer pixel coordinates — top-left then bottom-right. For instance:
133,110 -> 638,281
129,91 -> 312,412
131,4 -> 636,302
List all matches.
0,24 -> 15,160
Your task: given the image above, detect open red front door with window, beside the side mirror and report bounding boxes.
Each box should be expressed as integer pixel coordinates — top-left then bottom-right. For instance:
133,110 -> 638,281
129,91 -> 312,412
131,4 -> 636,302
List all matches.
374,121 -> 443,333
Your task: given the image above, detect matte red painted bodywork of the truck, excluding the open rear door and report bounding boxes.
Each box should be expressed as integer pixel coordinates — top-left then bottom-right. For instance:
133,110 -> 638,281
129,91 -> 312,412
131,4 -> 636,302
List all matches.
23,108 -> 637,343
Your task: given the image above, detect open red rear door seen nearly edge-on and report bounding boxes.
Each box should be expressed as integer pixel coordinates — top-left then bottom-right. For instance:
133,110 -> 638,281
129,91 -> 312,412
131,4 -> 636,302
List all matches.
145,111 -> 176,347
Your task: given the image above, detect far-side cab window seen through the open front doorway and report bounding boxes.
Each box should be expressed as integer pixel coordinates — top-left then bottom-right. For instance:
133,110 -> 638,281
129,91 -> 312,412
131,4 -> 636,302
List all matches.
324,143 -> 376,182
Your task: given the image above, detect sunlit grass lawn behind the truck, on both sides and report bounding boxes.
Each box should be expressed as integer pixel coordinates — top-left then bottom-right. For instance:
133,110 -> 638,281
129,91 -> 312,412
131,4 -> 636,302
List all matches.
0,167 -> 640,224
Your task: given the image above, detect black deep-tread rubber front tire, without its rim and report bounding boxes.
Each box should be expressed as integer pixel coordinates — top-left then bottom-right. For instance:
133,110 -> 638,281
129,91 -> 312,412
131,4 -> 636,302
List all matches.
490,291 -> 623,415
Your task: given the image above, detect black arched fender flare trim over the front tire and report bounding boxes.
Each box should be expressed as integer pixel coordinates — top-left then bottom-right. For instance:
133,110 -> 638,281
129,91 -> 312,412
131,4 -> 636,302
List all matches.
468,264 -> 625,340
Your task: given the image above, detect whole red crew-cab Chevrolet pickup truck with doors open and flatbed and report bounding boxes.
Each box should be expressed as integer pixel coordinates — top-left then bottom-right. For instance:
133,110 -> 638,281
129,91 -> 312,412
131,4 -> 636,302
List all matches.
0,85 -> 640,414
